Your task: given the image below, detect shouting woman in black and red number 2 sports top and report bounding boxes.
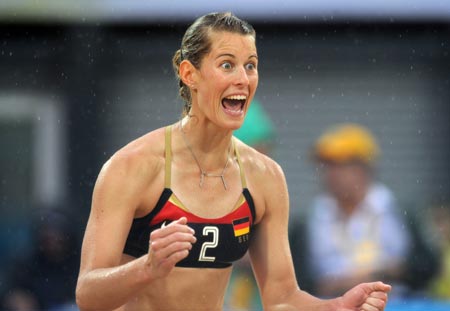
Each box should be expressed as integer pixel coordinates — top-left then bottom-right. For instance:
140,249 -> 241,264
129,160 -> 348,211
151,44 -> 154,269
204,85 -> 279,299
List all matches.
77,13 -> 390,311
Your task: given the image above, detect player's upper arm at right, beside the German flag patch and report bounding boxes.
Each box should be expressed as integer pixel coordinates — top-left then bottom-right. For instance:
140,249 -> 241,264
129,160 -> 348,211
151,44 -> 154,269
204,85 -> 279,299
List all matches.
250,162 -> 298,305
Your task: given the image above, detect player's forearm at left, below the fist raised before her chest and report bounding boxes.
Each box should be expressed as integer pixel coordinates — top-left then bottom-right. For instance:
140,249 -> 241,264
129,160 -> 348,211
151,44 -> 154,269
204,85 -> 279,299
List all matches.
76,256 -> 151,311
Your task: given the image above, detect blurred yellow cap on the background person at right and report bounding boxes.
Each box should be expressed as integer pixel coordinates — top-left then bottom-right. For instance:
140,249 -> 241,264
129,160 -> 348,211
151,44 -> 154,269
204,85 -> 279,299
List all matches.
314,123 -> 379,164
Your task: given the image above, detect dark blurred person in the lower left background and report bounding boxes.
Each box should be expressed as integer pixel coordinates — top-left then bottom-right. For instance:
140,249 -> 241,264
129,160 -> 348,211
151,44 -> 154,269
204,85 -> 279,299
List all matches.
2,209 -> 79,311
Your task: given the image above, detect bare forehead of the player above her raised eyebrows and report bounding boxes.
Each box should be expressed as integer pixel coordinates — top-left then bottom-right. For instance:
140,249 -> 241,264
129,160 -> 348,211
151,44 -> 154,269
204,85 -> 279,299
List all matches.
209,31 -> 256,56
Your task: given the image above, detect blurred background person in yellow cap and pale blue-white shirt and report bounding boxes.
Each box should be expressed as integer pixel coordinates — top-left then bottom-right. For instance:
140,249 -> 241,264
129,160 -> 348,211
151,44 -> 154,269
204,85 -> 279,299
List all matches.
306,124 -> 411,297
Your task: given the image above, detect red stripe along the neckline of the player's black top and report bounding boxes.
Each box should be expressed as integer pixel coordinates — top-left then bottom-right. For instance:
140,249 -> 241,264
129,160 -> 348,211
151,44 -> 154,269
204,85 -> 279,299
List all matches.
150,197 -> 251,226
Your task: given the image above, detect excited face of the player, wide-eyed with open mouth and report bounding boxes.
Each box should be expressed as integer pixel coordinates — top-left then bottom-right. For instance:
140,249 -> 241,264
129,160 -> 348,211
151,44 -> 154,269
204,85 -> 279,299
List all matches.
192,31 -> 258,130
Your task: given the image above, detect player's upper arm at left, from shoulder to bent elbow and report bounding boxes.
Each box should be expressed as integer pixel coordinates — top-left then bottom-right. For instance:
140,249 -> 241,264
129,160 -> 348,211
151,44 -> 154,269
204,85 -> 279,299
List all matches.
76,154 -> 156,276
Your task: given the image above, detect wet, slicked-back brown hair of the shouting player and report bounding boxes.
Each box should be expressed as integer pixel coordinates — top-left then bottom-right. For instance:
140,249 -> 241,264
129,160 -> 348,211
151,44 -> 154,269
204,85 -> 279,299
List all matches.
172,12 -> 256,116
